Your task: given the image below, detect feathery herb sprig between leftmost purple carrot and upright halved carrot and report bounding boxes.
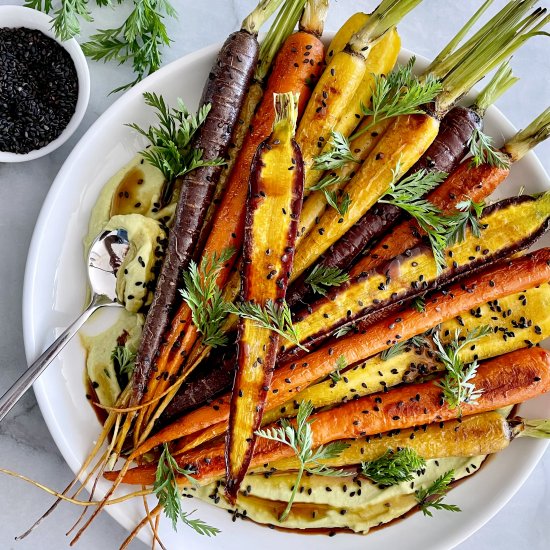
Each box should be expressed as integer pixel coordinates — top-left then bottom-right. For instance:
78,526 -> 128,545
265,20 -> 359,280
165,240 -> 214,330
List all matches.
181,248 -> 235,348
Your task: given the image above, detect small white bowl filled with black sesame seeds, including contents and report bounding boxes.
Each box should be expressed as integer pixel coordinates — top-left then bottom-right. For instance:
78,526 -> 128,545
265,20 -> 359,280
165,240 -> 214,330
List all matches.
0,6 -> 90,162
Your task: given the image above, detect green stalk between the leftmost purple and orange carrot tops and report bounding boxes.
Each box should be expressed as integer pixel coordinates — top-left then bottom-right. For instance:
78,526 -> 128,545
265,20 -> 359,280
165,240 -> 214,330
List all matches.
254,0 -> 306,83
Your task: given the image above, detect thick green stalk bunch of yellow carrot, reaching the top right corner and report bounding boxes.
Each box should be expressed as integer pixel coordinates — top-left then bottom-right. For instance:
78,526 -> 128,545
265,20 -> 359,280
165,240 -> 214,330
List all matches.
435,2 -> 549,116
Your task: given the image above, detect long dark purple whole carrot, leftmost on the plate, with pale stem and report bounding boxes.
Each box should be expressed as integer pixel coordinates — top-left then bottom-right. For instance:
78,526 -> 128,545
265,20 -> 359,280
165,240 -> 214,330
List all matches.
132,0 -> 281,404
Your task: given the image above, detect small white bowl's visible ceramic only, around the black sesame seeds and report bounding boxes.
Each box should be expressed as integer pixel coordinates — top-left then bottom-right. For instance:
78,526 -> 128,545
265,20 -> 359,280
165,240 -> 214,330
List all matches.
0,6 -> 90,162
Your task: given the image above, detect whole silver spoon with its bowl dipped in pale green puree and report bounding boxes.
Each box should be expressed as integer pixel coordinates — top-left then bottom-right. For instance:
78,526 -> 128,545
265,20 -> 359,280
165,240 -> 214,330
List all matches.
0,229 -> 130,421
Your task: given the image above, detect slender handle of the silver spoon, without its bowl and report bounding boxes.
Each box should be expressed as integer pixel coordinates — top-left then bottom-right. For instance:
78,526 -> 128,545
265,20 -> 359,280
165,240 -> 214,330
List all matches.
0,296 -> 120,421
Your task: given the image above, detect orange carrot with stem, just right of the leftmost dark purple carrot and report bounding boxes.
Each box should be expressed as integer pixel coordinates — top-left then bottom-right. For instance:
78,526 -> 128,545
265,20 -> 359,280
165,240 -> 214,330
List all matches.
130,0 -> 327,444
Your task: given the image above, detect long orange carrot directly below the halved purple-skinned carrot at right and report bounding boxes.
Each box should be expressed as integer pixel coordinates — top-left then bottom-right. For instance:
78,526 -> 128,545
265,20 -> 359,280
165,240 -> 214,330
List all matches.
134,248 -> 550,456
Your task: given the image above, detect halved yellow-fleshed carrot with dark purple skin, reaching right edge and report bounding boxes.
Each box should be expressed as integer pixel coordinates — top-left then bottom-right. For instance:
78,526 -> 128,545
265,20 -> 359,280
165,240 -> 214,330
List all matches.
279,195 -> 550,360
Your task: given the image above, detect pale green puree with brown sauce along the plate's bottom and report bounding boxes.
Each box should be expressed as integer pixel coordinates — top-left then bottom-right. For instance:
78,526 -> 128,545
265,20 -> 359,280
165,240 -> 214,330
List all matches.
184,456 -> 485,534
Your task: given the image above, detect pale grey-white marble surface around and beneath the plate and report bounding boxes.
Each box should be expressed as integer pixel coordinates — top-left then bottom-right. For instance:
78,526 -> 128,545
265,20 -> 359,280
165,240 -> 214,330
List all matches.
0,0 -> 550,550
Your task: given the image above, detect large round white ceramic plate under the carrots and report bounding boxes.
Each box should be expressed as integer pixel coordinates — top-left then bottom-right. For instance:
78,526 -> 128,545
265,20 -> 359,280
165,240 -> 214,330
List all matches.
23,40 -> 550,550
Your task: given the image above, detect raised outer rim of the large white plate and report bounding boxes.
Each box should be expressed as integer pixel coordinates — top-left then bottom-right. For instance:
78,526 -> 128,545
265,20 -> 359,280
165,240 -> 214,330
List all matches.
22,36 -> 550,549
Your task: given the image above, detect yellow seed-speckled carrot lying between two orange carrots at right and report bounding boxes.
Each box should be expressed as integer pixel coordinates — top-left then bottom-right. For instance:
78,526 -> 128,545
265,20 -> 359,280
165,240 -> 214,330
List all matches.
266,283 -> 550,424
